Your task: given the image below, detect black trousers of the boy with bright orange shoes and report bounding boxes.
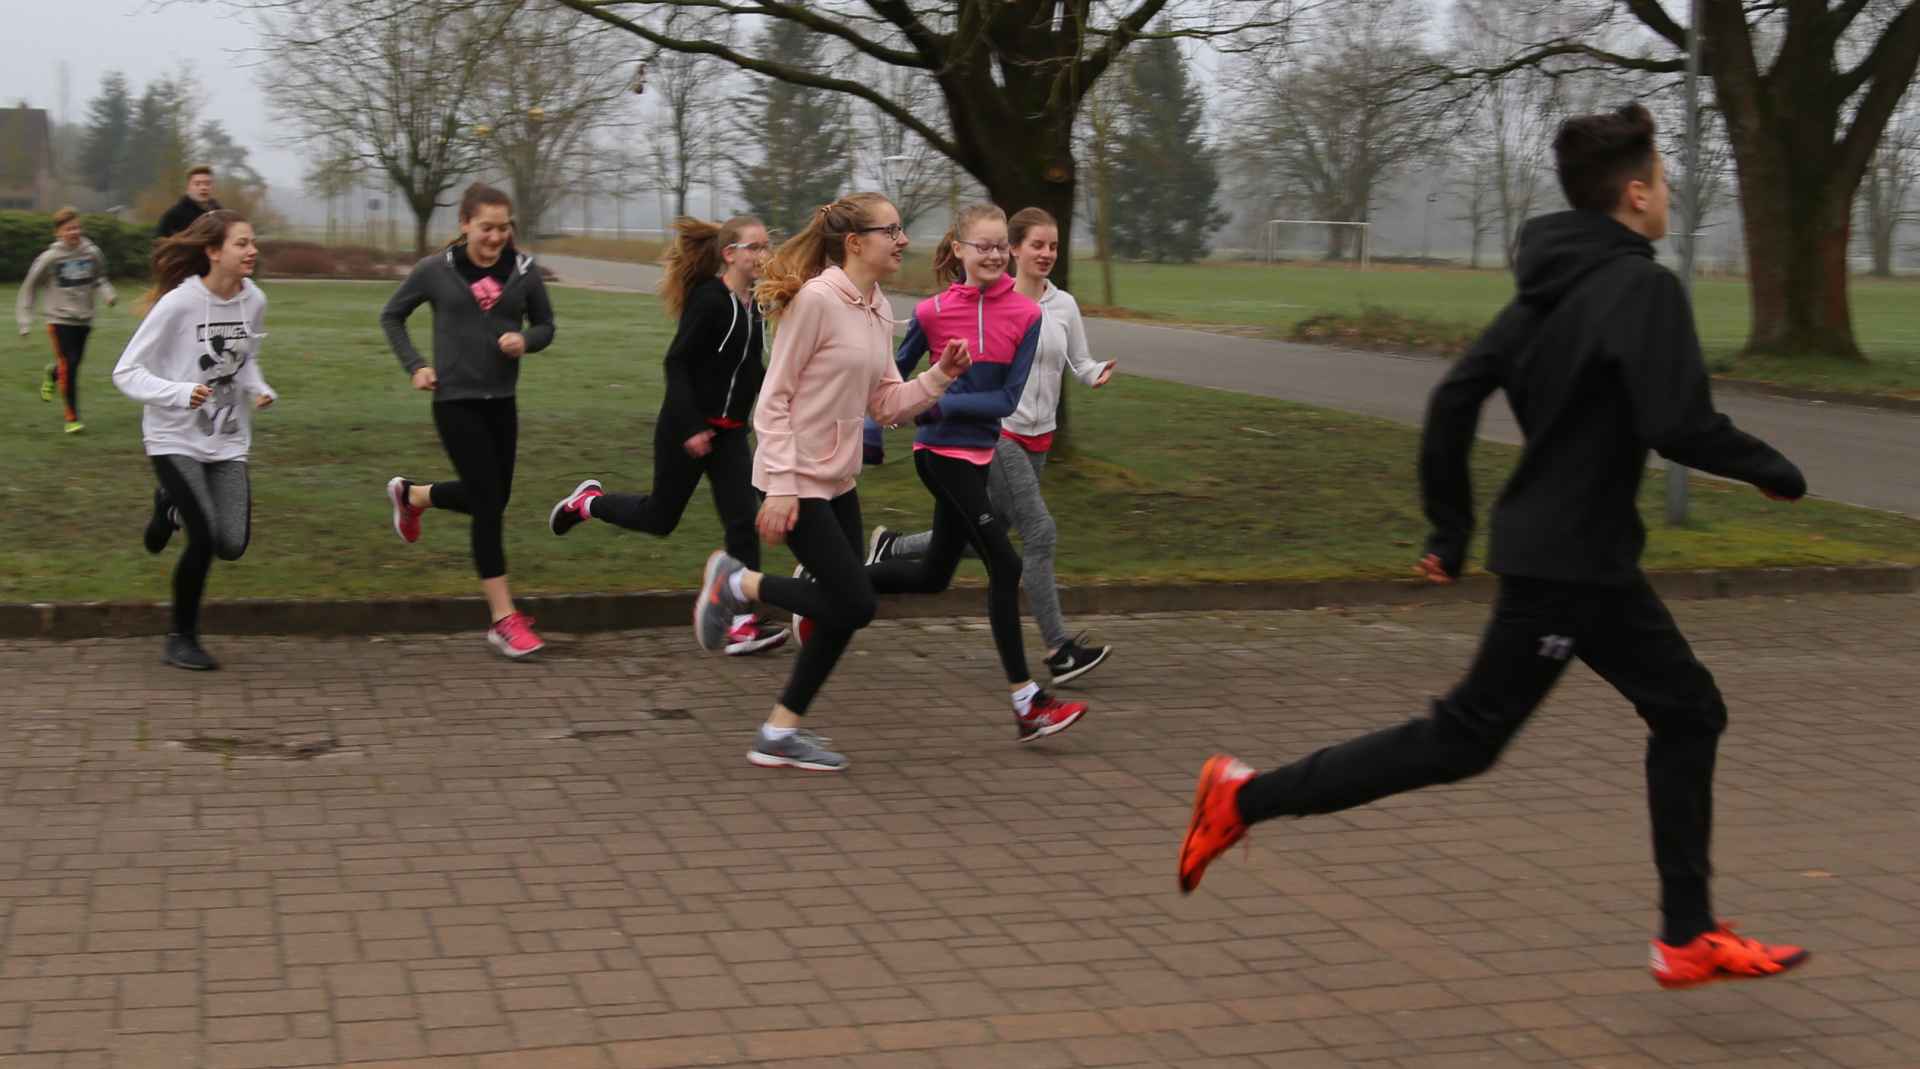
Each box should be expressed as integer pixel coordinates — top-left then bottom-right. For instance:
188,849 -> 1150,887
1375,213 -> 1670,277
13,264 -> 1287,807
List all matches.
1240,580 -> 1726,946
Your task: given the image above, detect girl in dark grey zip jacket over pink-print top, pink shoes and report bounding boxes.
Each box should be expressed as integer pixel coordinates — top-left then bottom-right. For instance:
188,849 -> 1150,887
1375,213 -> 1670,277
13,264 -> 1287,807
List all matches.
380,182 -> 553,658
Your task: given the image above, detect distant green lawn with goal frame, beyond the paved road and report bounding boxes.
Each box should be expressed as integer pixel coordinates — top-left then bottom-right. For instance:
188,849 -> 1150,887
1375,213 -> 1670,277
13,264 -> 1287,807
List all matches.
1098,261 -> 1920,397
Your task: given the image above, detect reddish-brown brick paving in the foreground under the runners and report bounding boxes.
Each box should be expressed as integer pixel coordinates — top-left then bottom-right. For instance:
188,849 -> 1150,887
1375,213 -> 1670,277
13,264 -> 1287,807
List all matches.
0,597 -> 1920,1069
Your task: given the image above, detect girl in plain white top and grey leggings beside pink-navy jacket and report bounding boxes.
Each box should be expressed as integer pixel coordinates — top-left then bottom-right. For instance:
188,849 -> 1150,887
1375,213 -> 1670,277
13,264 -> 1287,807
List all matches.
868,207 -> 1114,685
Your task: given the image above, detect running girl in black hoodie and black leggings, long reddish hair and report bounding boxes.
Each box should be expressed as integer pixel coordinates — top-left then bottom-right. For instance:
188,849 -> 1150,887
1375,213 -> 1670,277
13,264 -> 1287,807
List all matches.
547,215 -> 787,656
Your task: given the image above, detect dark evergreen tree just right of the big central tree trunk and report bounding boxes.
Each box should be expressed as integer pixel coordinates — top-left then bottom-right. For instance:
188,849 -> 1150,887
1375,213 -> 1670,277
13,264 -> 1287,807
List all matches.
1114,38 -> 1227,263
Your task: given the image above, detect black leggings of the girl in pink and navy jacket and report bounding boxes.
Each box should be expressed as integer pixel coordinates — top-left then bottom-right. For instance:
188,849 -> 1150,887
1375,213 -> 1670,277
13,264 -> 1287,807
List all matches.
866,449 -> 1033,683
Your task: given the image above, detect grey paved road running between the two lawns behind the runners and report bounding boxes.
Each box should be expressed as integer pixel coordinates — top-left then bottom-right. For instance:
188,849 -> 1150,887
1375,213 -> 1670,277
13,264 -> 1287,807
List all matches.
545,255 -> 1920,516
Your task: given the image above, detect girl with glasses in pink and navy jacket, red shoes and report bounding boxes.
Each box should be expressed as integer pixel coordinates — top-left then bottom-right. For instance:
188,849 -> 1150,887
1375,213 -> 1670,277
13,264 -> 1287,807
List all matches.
868,203 -> 1087,743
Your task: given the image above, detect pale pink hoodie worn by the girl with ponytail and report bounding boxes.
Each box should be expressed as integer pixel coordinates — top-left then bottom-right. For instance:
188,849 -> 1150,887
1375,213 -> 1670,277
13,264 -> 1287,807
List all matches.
753,267 -> 952,501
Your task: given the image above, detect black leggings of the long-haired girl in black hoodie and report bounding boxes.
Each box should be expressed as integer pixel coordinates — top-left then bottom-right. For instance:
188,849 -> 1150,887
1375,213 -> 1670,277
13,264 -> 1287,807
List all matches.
593,420 -> 760,572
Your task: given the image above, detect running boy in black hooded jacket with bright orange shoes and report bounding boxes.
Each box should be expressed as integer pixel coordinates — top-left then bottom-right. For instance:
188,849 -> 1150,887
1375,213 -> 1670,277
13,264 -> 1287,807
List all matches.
1181,104 -> 1807,988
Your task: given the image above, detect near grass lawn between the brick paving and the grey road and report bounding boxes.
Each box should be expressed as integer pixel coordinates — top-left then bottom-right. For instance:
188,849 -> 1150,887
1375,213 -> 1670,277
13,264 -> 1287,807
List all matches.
0,282 -> 1920,601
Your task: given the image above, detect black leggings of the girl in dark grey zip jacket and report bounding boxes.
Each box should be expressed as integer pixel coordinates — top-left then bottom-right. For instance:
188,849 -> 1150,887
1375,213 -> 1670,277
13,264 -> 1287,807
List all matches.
428,397 -> 520,580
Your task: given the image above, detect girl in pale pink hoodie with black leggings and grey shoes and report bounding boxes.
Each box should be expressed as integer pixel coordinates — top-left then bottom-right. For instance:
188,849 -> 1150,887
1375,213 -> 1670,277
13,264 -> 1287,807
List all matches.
693,194 -> 972,772
